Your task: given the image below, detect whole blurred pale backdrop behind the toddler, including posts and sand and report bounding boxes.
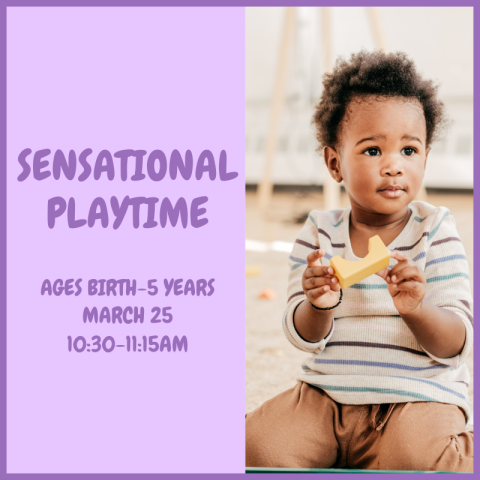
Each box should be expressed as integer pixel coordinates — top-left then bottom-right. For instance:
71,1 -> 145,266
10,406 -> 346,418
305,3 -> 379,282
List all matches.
245,7 -> 473,420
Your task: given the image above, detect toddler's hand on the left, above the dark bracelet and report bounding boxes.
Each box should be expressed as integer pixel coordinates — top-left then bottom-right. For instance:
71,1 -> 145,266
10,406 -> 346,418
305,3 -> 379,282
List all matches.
302,249 -> 340,308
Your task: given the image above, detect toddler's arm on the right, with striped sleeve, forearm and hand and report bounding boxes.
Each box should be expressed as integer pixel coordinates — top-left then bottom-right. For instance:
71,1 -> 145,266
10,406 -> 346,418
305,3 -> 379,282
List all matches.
380,208 -> 473,366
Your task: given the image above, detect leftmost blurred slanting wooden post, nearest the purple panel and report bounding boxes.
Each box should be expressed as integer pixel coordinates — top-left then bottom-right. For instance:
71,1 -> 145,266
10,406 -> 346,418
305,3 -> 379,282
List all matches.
257,7 -> 296,210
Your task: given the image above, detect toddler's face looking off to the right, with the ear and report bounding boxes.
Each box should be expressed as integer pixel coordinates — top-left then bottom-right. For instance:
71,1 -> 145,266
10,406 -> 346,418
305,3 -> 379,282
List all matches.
326,98 -> 430,215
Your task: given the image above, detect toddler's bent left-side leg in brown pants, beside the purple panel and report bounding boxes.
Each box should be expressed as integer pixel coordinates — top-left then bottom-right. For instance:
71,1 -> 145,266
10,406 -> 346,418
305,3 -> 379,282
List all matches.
245,382 -> 338,468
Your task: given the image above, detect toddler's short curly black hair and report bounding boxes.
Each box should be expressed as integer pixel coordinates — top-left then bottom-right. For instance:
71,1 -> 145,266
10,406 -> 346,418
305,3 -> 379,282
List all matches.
312,50 -> 449,151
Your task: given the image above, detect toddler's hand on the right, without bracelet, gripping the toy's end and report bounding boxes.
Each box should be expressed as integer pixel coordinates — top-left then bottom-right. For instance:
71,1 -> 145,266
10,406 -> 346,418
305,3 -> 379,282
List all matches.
377,250 -> 427,315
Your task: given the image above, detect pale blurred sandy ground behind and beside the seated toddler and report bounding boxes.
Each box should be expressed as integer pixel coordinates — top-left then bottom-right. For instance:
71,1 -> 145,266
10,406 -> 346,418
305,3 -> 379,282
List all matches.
245,192 -> 473,420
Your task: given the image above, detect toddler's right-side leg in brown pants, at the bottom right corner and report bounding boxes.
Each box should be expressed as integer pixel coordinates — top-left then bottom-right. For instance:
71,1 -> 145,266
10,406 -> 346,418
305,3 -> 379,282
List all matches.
351,402 -> 473,472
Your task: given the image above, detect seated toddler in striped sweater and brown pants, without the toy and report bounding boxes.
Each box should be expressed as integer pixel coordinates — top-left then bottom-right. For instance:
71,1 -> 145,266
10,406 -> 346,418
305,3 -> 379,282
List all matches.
246,52 -> 473,472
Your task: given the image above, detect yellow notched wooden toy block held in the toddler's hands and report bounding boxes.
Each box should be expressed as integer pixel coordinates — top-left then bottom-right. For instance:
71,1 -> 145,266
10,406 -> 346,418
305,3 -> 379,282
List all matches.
330,235 -> 390,288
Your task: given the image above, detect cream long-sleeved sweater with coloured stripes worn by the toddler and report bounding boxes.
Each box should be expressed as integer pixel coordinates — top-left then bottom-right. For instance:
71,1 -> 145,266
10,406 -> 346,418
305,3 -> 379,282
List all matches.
283,202 -> 473,419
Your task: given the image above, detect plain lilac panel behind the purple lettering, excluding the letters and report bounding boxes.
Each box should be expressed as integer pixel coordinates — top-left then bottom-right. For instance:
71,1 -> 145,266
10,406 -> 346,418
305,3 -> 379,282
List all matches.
7,7 -> 245,473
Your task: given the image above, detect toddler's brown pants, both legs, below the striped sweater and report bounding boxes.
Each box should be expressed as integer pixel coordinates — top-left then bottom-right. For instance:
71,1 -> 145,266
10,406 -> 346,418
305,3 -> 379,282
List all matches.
246,382 -> 473,472
